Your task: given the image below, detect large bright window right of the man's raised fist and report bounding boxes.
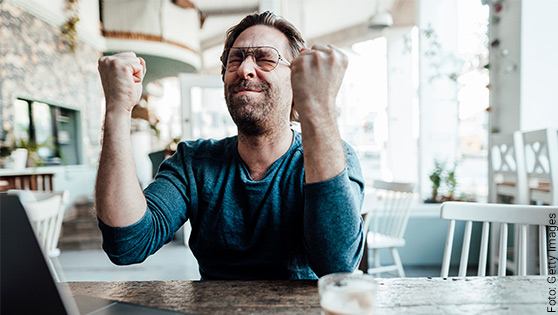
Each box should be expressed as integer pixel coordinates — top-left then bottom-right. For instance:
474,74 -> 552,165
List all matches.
337,0 -> 488,201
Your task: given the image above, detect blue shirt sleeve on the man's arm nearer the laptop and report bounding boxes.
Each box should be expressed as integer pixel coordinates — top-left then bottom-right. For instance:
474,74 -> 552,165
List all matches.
98,143 -> 191,265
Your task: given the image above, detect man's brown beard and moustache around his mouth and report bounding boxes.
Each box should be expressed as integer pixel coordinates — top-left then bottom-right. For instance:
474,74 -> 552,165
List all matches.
225,80 -> 281,136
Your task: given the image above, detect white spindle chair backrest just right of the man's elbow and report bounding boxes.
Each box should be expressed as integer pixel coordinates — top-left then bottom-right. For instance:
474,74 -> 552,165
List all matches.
364,180 -> 415,238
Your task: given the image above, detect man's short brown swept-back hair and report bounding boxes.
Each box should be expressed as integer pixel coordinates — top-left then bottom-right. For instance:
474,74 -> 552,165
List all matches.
221,11 -> 304,76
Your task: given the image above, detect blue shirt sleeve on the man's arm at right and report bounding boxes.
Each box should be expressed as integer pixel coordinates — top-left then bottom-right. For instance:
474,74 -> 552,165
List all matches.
304,144 -> 364,277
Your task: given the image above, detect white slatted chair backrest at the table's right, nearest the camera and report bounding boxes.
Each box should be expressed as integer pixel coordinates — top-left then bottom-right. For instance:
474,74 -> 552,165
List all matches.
440,202 -> 558,278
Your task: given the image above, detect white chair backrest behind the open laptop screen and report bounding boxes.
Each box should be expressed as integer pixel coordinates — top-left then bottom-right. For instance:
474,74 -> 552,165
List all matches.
8,190 -> 69,256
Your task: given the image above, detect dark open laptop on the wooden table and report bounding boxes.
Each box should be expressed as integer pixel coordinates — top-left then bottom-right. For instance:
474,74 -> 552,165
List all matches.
0,194 -> 181,315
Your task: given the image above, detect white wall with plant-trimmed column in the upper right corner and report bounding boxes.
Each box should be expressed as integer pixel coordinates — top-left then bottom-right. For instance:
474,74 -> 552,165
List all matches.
490,0 -> 558,133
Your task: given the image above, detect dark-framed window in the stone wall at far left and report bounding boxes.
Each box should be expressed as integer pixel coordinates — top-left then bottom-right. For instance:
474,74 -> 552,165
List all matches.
14,99 -> 80,165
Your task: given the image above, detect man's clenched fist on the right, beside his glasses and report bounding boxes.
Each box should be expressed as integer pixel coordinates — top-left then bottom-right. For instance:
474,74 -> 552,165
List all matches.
291,45 -> 349,122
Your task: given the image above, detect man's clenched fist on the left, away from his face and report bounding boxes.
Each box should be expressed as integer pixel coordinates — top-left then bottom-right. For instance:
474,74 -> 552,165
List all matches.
99,52 -> 147,115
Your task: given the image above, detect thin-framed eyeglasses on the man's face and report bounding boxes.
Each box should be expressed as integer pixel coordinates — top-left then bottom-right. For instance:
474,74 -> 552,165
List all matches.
221,46 -> 291,72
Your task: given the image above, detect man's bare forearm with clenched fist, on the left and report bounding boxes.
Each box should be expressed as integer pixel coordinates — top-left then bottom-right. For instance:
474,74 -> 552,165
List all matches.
95,52 -> 147,227
